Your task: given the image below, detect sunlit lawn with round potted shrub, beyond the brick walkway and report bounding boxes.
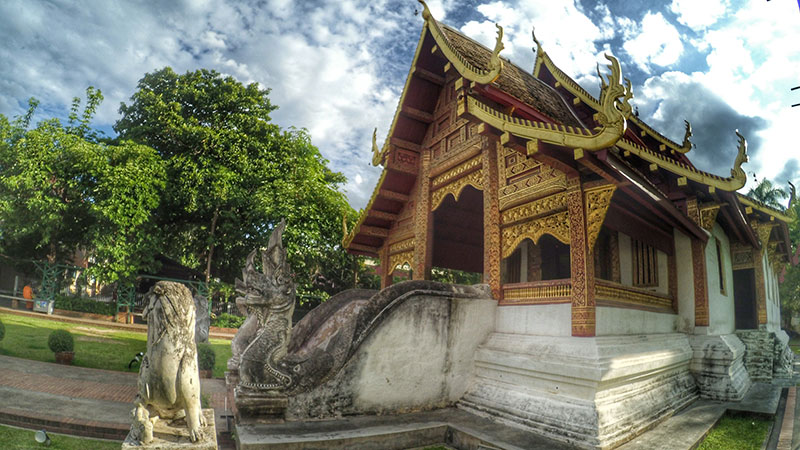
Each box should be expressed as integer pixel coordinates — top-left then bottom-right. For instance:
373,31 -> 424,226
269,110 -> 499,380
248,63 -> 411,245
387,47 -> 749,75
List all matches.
0,313 -> 231,376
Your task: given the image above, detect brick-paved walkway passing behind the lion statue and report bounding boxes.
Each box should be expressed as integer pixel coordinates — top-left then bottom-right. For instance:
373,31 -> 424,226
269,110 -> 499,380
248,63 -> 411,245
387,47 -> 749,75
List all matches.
0,355 -> 227,441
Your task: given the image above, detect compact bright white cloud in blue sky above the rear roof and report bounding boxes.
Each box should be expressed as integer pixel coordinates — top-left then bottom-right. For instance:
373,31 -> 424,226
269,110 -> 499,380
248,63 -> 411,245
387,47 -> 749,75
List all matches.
622,12 -> 683,73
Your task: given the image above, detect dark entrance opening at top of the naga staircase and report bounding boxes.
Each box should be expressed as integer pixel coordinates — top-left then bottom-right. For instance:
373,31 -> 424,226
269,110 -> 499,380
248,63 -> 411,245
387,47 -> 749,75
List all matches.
431,186 -> 483,284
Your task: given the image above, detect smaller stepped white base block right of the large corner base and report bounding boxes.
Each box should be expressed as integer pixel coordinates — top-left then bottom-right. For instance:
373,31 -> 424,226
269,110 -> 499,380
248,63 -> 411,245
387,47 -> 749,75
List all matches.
689,334 -> 752,401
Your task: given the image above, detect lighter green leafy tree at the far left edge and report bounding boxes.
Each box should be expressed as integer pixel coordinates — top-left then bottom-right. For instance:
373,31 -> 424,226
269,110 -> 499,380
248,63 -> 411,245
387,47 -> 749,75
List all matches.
0,87 -> 165,282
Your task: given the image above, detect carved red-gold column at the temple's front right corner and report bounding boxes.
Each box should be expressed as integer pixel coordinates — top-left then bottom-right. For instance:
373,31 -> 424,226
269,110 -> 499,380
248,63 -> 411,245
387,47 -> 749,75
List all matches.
567,176 -> 595,337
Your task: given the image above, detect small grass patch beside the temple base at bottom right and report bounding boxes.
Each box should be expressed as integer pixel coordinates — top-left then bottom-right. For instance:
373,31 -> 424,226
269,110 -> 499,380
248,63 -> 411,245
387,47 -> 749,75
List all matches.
697,415 -> 772,450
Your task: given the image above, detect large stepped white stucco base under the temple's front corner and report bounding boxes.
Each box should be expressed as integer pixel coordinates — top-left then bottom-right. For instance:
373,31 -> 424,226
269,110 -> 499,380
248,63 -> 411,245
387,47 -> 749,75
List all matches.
458,333 -> 697,448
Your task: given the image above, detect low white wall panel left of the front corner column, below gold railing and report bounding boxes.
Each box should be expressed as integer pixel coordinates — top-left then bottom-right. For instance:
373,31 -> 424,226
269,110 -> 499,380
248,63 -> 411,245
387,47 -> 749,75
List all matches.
496,303 -> 572,336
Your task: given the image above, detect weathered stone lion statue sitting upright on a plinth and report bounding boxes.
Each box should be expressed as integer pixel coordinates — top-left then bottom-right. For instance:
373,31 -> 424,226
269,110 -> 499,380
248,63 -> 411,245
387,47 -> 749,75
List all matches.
132,281 -> 205,444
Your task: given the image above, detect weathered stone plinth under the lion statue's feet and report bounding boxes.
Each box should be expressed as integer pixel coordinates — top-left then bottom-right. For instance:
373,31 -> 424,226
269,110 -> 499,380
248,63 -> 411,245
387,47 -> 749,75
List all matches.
122,408 -> 217,450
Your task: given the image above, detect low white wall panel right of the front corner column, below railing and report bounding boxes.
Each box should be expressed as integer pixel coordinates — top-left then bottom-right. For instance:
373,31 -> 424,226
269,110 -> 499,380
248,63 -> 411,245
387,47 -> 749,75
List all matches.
595,306 -> 678,336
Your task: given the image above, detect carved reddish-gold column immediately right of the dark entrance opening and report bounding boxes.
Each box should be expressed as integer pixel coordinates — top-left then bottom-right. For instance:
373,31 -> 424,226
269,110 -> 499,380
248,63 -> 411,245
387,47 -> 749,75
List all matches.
481,136 -> 502,300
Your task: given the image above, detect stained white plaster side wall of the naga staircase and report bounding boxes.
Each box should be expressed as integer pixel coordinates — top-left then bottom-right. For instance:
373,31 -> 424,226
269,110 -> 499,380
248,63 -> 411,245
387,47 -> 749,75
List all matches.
286,294 -> 497,420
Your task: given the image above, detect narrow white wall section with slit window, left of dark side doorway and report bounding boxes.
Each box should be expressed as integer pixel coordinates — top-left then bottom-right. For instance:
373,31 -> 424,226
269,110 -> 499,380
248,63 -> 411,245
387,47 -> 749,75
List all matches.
705,223 -> 736,334
